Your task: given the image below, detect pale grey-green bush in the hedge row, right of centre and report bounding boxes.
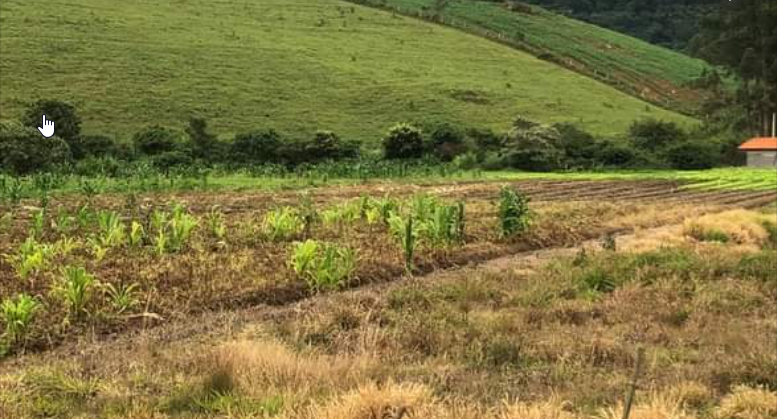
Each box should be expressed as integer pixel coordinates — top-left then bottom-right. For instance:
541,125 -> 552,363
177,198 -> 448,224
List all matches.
503,118 -> 563,171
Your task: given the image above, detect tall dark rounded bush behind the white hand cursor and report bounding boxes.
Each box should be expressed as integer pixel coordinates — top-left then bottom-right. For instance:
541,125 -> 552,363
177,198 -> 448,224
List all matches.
22,100 -> 83,158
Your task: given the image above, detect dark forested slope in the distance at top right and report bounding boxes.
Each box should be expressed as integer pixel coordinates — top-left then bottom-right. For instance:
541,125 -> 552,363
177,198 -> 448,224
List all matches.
523,0 -> 721,50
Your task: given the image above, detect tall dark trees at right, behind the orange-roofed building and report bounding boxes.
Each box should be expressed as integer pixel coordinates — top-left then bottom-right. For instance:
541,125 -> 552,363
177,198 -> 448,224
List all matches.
693,0 -> 777,134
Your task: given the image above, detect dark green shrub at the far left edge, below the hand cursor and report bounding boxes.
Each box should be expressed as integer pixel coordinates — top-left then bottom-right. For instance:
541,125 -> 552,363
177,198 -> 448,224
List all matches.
0,122 -> 71,175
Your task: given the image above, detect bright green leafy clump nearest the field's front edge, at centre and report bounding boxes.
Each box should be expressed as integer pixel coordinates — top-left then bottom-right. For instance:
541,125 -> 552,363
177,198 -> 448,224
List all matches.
289,240 -> 356,291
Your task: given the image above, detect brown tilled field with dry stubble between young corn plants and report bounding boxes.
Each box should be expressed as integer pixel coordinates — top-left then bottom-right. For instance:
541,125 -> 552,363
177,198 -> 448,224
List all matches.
0,181 -> 777,350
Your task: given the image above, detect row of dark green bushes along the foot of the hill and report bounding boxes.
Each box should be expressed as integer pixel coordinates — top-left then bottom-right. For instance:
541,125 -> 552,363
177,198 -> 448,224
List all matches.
0,101 -> 739,176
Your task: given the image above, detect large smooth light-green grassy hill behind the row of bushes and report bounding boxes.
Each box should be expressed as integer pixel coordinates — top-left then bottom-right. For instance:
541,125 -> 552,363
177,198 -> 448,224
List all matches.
0,0 -> 695,141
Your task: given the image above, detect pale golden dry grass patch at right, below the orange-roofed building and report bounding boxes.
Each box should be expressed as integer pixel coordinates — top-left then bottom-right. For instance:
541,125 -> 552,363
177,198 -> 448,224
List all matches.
683,209 -> 777,246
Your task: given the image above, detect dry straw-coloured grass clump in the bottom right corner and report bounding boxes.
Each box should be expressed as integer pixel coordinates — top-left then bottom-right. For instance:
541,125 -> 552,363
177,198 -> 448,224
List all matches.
715,386 -> 777,419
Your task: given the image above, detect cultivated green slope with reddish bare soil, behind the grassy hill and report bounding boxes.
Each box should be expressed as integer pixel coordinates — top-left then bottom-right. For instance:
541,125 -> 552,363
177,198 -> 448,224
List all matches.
348,0 -> 707,113
